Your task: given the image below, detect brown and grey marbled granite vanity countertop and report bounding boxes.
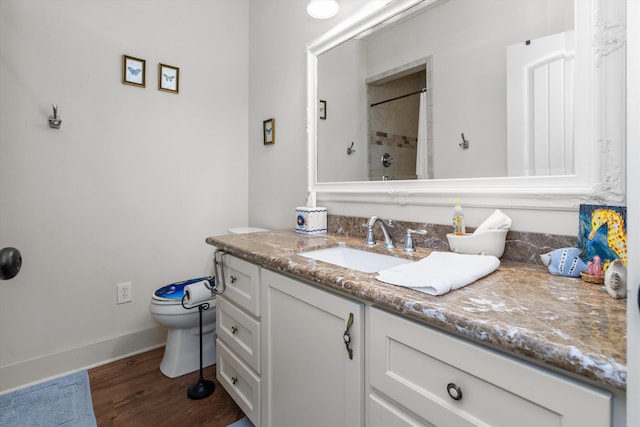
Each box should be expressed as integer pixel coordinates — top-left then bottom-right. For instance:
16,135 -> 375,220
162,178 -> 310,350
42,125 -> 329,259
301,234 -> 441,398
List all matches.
206,230 -> 627,390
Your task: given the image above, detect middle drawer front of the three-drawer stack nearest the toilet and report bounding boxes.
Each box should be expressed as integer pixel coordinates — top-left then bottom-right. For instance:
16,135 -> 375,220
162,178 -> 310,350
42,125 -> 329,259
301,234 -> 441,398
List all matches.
216,296 -> 260,374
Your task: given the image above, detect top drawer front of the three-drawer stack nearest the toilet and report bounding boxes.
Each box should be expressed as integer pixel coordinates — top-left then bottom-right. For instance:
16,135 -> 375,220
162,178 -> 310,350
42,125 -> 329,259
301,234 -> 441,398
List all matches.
223,254 -> 260,317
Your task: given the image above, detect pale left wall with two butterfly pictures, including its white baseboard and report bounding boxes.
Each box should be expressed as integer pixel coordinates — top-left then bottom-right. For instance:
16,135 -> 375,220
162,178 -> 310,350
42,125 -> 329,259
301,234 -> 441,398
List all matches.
0,0 -> 249,391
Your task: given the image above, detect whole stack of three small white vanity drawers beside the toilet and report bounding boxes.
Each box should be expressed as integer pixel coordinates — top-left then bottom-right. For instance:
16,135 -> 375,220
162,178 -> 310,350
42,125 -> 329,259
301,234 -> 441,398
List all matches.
216,254 -> 262,427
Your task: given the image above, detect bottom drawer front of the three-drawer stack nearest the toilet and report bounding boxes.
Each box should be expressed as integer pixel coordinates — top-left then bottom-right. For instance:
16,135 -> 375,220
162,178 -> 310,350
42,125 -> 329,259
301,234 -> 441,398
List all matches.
216,339 -> 260,427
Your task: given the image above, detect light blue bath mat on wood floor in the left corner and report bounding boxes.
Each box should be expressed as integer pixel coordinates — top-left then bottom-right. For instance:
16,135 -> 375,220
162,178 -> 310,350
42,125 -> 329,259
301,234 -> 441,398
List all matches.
0,371 -> 96,427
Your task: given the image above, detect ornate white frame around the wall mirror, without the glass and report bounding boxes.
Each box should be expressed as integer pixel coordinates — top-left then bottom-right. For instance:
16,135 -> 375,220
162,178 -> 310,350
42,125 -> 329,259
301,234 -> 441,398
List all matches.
307,0 -> 626,210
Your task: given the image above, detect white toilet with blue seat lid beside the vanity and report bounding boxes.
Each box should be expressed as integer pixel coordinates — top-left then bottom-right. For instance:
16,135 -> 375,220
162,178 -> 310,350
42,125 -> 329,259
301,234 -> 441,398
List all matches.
149,277 -> 216,378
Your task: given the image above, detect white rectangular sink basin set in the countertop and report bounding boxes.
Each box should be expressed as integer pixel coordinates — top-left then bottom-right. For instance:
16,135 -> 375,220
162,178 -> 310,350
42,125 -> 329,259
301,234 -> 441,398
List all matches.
299,246 -> 413,273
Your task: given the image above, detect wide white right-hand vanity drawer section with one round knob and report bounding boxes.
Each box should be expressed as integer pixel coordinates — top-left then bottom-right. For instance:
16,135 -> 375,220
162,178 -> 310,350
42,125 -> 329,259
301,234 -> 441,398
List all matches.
367,307 -> 612,427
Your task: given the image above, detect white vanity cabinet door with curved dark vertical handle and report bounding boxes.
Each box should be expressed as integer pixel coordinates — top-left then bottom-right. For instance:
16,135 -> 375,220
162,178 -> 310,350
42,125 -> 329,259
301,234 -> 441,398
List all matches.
262,270 -> 364,427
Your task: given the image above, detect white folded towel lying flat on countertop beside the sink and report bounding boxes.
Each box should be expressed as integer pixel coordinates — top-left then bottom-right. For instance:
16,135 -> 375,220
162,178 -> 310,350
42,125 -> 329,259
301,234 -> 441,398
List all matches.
376,252 -> 500,295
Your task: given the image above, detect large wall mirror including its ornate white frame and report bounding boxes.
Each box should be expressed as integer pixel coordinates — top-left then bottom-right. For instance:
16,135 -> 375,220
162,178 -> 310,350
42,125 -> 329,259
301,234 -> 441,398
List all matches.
308,0 -> 625,209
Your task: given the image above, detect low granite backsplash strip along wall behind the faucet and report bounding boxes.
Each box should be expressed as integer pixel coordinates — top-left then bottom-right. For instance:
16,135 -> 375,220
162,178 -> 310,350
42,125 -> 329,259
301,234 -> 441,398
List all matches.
327,214 -> 578,265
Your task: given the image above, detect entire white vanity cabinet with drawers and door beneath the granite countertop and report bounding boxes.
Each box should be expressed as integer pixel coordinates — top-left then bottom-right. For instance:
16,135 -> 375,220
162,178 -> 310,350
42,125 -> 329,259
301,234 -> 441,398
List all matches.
216,254 -> 620,427
